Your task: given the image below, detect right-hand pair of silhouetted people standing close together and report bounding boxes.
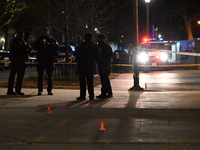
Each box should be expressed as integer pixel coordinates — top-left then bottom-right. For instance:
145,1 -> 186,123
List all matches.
75,33 -> 113,100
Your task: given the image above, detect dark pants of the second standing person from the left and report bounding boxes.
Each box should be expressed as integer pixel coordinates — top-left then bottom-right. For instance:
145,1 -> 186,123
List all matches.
37,63 -> 54,93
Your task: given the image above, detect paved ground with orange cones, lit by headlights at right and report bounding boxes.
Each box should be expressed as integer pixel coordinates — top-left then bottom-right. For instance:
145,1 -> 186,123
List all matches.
0,70 -> 200,150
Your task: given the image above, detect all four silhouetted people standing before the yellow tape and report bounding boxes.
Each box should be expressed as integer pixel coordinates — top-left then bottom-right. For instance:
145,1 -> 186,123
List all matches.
7,28 -> 113,101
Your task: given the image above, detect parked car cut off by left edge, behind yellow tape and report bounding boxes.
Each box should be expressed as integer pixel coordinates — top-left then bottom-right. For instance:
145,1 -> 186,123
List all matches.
0,50 -> 10,70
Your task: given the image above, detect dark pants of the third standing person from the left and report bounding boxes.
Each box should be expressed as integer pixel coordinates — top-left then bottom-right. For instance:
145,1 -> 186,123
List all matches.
79,73 -> 94,98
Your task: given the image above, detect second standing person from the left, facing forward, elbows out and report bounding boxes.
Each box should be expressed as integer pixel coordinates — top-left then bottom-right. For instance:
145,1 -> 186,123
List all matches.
32,28 -> 59,95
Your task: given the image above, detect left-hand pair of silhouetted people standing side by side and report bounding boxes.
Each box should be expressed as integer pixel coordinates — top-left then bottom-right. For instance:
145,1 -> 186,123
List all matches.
7,28 -> 59,95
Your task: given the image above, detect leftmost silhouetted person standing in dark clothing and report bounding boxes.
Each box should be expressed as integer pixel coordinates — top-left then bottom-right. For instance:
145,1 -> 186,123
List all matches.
7,30 -> 31,95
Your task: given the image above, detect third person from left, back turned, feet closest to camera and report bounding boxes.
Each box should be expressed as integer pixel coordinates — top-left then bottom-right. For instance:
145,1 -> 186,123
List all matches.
75,33 -> 100,100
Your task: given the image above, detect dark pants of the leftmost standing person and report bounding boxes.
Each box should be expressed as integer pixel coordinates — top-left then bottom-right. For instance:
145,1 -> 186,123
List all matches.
8,62 -> 26,93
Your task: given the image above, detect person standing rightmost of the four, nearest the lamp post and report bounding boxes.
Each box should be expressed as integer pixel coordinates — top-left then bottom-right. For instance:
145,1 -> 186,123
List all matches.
97,34 -> 113,98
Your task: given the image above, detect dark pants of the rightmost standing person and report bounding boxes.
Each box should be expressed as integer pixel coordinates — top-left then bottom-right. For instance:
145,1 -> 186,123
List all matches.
99,73 -> 112,96
